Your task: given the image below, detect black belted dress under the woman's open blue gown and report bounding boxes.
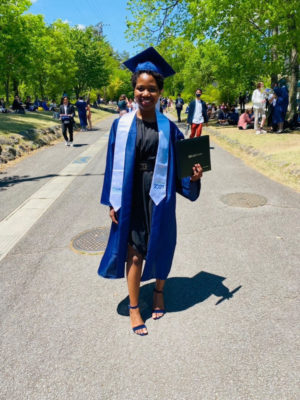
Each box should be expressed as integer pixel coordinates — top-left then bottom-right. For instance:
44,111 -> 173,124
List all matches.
129,118 -> 158,258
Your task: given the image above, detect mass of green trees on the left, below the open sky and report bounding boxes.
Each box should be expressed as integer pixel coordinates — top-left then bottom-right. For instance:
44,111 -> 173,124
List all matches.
0,0 -> 131,101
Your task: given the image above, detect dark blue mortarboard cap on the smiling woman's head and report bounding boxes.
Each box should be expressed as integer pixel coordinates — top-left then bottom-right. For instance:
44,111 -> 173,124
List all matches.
123,47 -> 175,78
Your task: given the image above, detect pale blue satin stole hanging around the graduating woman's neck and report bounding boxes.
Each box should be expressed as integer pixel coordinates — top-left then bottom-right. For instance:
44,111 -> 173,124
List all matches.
109,111 -> 170,211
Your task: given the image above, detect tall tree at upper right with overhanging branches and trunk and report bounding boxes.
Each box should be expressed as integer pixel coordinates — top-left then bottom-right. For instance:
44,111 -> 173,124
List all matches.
127,0 -> 300,117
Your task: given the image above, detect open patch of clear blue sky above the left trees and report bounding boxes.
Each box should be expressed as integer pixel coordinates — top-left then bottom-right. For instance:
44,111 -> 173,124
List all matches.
29,0 -> 137,55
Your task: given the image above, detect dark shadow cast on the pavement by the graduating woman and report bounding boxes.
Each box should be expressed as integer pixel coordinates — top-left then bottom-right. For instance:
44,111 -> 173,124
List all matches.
117,271 -> 242,320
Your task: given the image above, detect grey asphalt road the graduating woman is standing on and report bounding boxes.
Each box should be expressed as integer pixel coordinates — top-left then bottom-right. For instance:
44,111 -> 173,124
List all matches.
0,113 -> 300,400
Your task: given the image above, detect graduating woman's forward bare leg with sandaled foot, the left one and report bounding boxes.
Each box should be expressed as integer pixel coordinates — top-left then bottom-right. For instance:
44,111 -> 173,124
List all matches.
126,246 -> 147,334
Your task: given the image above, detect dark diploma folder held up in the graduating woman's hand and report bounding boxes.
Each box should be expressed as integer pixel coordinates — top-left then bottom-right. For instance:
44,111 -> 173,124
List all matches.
175,135 -> 211,179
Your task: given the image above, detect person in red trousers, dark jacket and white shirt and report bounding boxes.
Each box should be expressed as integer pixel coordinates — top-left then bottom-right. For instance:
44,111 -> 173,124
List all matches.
187,89 -> 208,139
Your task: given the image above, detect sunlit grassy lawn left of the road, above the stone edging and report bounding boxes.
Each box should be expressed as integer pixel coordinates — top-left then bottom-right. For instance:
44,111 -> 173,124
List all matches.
0,108 -> 110,135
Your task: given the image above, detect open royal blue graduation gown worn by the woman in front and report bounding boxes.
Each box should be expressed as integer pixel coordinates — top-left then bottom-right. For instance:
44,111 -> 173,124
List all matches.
98,112 -> 200,281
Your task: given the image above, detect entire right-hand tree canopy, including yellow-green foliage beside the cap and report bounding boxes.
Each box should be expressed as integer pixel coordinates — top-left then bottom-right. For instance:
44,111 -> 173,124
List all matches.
127,0 -> 300,115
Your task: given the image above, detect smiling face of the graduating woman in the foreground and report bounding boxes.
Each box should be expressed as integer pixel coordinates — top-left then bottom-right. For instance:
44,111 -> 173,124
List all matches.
134,72 -> 161,111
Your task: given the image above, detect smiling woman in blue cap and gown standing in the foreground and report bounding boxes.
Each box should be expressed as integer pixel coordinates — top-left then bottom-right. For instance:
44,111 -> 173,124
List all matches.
98,47 -> 202,336
